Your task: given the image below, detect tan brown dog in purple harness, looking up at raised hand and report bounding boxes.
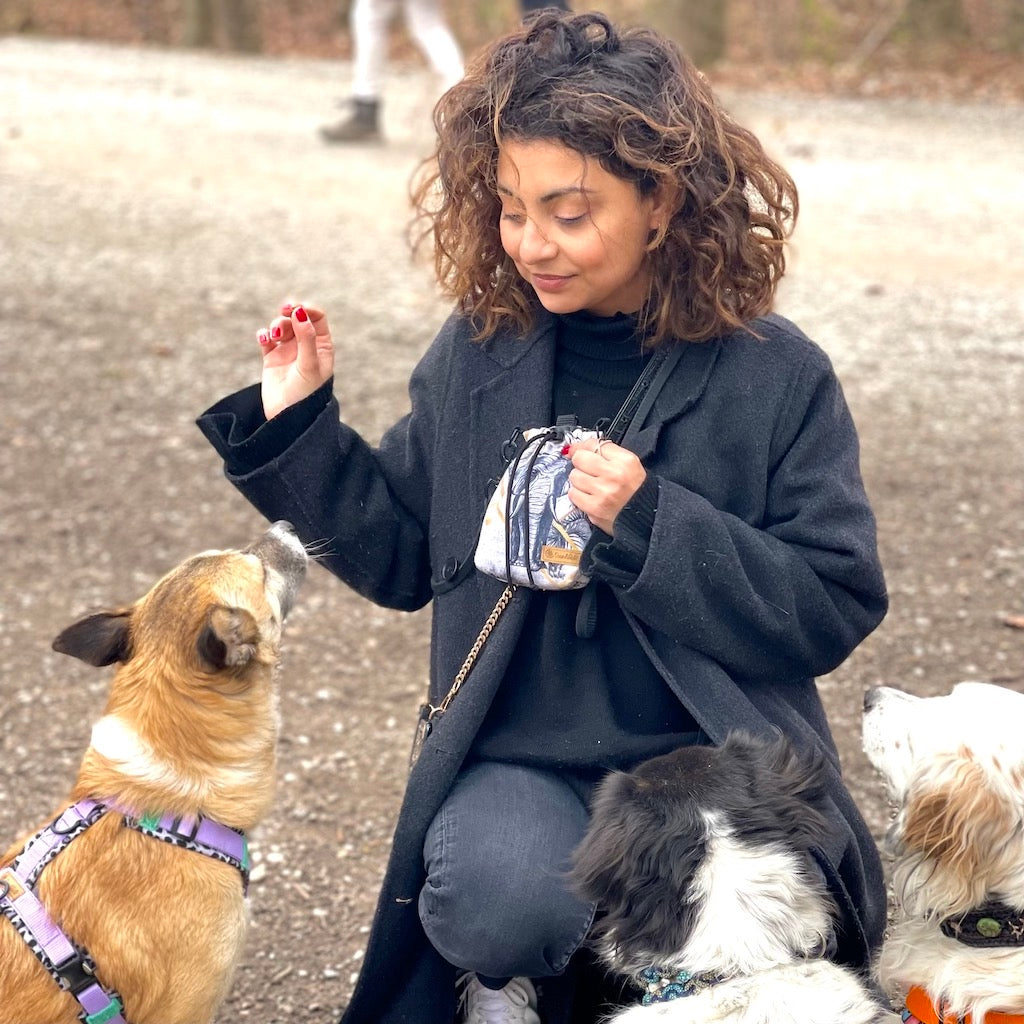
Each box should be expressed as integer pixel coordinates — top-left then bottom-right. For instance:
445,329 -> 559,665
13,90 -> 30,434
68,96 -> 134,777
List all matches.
0,523 -> 307,1024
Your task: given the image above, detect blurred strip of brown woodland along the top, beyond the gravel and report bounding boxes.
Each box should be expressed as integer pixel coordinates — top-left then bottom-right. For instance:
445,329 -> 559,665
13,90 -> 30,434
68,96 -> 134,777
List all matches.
0,0 -> 1024,92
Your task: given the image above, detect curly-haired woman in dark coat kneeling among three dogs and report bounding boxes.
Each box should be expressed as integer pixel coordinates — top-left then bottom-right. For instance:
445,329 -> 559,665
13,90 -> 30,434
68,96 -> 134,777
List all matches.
200,11 -> 887,1024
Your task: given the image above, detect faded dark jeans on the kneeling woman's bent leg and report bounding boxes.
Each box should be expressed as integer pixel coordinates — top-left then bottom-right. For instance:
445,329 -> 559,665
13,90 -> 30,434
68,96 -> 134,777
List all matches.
419,763 -> 594,978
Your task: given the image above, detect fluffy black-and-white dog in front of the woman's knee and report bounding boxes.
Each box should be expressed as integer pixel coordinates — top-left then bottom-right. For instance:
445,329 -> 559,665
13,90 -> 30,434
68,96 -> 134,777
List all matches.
572,733 -> 882,1024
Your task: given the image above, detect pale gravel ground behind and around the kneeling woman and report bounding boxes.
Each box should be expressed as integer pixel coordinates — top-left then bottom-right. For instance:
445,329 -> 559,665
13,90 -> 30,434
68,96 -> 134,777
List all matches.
0,38 -> 1024,1024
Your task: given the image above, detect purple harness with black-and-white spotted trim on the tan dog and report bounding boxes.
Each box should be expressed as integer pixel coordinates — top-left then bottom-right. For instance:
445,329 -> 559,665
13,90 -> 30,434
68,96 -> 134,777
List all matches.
0,800 -> 249,1024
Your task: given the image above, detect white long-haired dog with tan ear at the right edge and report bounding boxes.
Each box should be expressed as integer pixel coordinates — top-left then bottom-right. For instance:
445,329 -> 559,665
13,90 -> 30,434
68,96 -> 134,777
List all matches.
863,682 -> 1024,1022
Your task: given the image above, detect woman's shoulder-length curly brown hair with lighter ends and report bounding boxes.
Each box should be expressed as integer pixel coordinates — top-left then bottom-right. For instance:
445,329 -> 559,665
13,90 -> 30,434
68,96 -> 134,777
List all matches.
413,10 -> 798,345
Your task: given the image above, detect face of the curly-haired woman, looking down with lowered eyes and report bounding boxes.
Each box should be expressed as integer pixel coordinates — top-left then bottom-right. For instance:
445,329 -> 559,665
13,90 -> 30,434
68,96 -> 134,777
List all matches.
498,139 -> 665,316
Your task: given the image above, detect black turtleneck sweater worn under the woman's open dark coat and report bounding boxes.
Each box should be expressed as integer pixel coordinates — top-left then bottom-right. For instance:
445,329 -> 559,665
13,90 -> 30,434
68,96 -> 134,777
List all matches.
472,313 -> 697,775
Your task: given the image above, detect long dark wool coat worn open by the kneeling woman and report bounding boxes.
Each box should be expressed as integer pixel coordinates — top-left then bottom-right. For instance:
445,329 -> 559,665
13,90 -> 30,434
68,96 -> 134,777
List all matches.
199,313 -> 887,1024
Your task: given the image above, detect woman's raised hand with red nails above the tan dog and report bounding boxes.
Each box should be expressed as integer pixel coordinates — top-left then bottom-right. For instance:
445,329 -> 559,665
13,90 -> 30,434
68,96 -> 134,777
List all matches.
256,302 -> 334,420
